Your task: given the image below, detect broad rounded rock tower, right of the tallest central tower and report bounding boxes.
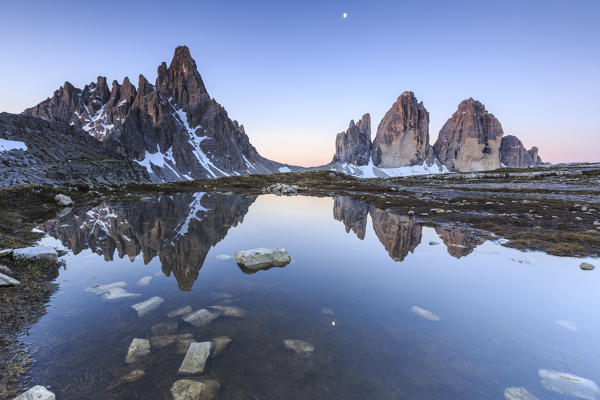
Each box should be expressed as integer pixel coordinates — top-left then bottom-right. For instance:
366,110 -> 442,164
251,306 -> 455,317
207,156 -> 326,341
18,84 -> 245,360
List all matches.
433,98 -> 504,172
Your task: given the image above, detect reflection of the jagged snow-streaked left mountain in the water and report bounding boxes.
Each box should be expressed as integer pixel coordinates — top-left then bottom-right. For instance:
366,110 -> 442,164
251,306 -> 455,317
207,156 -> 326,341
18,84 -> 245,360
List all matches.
41,193 -> 256,291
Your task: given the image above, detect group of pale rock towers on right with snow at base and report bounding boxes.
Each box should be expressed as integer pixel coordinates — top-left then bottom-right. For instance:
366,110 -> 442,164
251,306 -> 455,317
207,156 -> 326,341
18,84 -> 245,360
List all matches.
322,91 -> 542,177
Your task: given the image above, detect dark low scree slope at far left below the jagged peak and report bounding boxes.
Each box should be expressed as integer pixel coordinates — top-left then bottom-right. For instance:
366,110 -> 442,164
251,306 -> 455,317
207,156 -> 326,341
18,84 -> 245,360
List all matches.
0,113 -> 150,187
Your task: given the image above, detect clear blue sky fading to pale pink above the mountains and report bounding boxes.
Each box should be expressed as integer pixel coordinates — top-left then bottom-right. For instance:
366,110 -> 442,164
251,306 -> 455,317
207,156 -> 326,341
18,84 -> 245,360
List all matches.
0,0 -> 600,166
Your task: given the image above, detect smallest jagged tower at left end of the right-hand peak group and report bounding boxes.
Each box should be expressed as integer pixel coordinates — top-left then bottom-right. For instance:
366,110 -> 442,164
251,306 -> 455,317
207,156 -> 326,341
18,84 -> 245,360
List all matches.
332,114 -> 371,165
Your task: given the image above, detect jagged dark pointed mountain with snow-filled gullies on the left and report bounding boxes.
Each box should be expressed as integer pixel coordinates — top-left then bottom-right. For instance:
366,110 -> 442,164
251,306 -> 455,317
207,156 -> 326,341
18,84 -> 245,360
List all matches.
24,46 -> 284,181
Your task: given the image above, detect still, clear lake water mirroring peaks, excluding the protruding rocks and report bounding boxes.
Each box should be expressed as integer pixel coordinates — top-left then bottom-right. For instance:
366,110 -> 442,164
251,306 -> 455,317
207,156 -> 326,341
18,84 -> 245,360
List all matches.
23,193 -> 600,399
